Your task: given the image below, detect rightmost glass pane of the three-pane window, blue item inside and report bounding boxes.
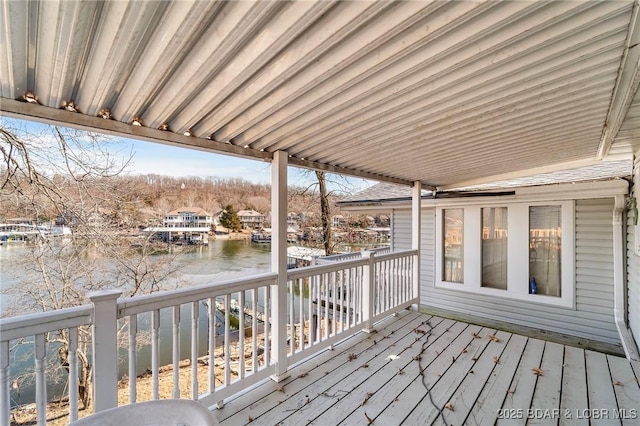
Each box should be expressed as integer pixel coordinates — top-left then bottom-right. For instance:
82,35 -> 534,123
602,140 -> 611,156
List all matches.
529,206 -> 562,297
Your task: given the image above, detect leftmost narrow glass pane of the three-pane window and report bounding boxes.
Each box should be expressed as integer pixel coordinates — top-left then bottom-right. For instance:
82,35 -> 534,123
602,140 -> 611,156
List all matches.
442,209 -> 464,283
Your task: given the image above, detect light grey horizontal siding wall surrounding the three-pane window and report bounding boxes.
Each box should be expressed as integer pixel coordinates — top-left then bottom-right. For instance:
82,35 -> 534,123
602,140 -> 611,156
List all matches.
392,198 -> 620,344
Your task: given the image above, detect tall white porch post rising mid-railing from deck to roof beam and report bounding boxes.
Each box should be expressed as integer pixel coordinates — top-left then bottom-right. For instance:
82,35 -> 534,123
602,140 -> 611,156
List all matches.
271,151 -> 288,382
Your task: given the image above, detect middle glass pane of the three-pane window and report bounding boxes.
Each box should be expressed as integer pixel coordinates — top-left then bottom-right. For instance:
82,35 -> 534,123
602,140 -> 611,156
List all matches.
480,207 -> 508,290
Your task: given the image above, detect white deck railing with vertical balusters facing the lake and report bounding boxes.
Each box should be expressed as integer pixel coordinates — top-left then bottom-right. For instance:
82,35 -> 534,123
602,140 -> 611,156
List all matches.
0,250 -> 418,424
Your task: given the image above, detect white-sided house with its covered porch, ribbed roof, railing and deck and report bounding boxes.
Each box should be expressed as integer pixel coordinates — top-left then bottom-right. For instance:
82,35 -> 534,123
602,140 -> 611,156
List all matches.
0,0 -> 640,425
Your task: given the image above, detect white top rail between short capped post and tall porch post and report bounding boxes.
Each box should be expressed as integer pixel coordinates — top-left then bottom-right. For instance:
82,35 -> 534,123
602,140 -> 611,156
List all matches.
118,272 -> 277,318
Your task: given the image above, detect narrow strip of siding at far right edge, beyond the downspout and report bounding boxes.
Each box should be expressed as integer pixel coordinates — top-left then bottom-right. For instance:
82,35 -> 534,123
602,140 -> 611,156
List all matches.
627,155 -> 640,346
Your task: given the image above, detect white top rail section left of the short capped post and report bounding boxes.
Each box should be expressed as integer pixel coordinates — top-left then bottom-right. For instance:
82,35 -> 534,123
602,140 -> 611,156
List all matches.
0,305 -> 93,342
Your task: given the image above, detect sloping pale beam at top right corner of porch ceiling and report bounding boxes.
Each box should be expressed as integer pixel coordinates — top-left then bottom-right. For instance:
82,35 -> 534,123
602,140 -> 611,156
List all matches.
596,1 -> 640,160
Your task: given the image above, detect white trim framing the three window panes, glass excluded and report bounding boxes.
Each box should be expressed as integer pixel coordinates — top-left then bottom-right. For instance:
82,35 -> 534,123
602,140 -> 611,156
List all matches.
435,200 -> 576,309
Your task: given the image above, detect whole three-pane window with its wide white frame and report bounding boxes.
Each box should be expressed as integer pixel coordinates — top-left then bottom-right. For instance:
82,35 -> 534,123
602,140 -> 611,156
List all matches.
434,200 -> 575,308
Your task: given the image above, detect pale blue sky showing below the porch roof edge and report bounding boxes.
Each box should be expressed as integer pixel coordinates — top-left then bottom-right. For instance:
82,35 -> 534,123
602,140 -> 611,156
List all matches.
0,117 -> 375,192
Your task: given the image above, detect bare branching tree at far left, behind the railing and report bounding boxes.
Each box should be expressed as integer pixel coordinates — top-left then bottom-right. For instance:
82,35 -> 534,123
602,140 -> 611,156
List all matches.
0,118 -> 176,408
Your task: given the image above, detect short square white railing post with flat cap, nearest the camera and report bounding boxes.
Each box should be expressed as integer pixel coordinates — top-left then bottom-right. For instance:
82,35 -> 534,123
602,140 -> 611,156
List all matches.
89,290 -> 122,413
